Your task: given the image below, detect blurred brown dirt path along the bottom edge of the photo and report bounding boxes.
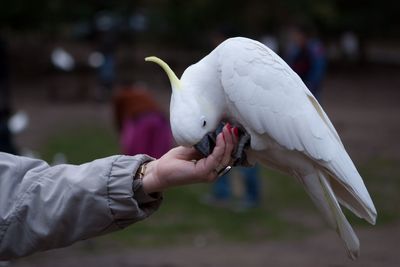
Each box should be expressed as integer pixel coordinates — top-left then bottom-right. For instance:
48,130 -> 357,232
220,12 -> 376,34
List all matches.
12,224 -> 400,267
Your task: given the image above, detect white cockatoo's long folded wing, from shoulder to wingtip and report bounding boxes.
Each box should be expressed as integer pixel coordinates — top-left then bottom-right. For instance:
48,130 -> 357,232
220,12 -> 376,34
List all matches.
216,37 -> 376,223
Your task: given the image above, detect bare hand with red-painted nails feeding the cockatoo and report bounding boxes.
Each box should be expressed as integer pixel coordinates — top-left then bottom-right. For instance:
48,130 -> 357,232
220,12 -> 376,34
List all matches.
143,124 -> 238,193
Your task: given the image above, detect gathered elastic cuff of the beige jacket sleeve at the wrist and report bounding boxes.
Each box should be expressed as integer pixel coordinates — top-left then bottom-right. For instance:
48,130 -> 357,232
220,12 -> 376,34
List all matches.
107,155 -> 162,228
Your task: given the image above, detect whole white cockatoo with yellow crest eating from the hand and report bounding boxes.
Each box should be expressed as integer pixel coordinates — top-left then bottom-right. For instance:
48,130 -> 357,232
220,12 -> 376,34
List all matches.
146,37 -> 377,259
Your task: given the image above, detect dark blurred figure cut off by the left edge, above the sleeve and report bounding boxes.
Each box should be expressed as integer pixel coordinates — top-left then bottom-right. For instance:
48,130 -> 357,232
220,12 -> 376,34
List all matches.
0,36 -> 17,154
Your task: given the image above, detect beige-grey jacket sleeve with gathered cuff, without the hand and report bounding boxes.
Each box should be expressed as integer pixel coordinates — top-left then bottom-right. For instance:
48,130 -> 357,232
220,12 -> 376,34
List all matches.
0,153 -> 162,260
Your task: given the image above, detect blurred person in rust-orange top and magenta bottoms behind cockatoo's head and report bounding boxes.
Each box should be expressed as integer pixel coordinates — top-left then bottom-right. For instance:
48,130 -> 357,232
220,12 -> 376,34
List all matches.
113,84 -> 173,158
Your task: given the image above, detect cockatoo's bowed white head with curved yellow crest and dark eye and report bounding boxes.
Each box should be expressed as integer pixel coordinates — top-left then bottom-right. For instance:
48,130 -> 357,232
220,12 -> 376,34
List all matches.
145,57 -> 221,146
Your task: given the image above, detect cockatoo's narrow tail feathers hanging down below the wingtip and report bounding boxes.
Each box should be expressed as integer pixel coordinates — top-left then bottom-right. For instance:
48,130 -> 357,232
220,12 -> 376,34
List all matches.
301,170 -> 360,260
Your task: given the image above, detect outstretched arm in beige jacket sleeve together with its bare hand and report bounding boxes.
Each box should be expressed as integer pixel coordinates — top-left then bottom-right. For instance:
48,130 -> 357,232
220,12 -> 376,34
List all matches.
0,124 -> 238,260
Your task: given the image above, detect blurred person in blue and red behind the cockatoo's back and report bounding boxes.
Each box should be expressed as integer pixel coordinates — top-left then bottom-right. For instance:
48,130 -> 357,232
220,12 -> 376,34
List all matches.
284,25 -> 326,101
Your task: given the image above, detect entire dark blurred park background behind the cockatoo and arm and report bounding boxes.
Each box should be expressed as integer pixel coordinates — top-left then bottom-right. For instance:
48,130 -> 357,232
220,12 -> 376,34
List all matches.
0,0 -> 400,267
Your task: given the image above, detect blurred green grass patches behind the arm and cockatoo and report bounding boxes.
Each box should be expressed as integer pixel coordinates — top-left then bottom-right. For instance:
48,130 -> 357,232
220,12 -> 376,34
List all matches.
41,126 -> 400,250
